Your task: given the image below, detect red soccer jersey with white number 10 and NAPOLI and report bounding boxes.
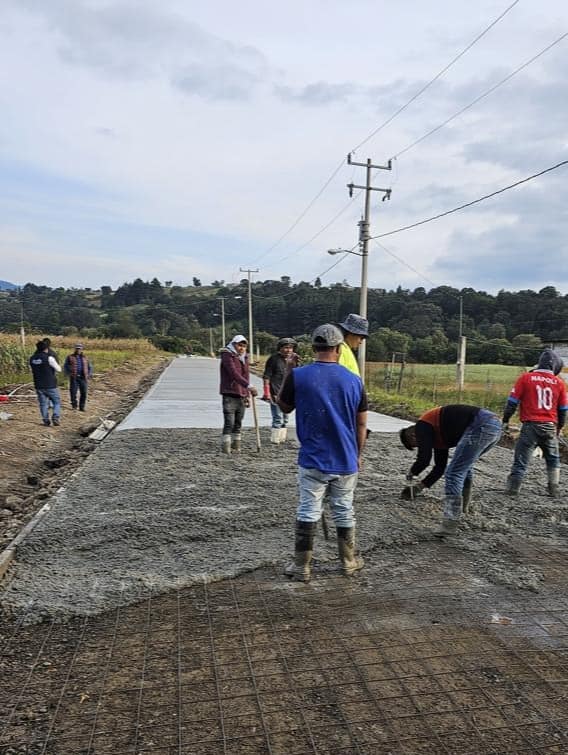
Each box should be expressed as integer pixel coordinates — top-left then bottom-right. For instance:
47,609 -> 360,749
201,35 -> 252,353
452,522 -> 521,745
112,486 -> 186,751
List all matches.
509,370 -> 568,424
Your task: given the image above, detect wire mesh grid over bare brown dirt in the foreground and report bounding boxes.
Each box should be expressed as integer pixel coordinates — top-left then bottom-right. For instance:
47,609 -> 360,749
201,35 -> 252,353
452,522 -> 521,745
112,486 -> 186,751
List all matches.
0,546 -> 568,755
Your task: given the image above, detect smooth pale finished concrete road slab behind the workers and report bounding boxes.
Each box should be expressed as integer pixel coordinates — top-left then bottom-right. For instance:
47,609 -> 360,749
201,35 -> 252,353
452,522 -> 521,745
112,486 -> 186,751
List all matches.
117,357 -> 410,433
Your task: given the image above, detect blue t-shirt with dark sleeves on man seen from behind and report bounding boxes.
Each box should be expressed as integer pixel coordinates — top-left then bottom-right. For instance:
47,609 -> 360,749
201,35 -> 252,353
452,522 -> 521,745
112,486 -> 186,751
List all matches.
280,362 -> 367,475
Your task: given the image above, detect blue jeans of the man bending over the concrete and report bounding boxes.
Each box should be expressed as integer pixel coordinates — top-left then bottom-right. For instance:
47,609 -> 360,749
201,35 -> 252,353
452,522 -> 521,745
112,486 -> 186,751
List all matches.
445,409 -> 503,496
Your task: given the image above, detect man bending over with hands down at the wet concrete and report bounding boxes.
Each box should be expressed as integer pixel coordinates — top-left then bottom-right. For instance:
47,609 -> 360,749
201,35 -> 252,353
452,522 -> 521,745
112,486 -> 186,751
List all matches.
399,404 -> 502,537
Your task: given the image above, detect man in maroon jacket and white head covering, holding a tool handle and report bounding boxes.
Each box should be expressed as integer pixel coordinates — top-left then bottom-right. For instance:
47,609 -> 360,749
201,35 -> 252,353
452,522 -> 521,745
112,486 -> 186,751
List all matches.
219,335 -> 257,454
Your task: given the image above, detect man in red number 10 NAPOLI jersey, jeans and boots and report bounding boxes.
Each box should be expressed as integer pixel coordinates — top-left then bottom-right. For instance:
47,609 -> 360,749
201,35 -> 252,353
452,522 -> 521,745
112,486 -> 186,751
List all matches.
503,349 -> 568,498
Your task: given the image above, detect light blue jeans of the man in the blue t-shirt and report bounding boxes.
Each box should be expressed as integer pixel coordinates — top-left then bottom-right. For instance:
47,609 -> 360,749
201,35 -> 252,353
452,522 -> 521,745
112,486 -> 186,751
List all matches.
296,467 -> 358,528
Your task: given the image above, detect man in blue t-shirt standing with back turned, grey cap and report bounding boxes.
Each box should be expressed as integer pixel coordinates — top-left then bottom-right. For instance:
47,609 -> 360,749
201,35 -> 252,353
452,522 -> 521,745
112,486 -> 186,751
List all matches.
276,324 -> 367,582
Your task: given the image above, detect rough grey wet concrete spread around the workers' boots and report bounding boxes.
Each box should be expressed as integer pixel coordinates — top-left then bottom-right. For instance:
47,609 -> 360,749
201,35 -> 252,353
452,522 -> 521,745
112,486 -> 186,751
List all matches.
2,422 -> 568,620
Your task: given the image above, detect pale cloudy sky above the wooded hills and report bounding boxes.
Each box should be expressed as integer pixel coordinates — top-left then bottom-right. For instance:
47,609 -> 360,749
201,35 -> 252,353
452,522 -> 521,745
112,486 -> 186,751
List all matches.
0,0 -> 568,293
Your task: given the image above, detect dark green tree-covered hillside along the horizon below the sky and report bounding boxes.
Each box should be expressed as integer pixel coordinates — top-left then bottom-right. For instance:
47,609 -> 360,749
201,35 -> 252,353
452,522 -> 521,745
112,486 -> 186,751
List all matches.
0,276 -> 568,365
